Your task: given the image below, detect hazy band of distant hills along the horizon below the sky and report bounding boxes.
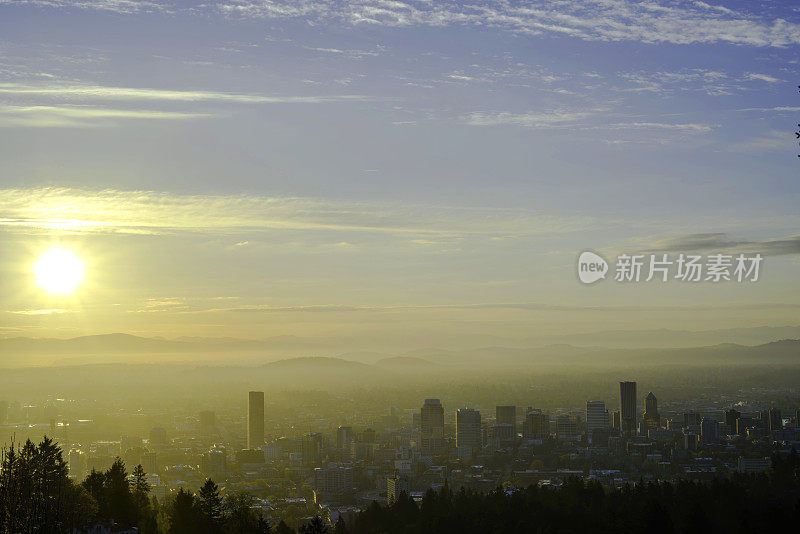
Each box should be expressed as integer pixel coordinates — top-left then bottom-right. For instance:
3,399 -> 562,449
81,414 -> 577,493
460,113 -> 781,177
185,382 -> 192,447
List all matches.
0,334 -> 800,372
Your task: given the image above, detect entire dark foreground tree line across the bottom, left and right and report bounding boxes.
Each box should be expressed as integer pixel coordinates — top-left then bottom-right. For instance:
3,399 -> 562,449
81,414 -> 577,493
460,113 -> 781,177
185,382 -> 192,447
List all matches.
0,438 -> 800,534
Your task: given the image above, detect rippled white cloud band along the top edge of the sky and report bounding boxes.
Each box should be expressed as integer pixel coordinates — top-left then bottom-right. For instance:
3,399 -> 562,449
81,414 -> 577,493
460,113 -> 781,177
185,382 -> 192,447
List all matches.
6,0 -> 800,47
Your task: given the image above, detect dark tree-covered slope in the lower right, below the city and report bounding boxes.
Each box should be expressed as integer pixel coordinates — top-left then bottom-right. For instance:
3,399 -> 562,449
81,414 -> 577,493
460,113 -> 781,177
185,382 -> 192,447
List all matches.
344,451 -> 800,534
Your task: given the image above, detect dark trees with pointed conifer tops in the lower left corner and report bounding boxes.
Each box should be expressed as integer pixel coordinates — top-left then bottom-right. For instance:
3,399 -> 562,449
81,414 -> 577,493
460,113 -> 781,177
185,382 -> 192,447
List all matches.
0,437 -> 325,534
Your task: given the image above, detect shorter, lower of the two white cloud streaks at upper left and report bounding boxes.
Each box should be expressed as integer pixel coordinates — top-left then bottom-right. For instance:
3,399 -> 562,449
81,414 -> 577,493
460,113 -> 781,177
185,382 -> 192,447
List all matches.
0,105 -> 211,128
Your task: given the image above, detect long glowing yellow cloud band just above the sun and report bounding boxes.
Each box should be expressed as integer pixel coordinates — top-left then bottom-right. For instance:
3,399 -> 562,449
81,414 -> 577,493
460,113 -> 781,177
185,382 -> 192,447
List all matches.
0,188 -> 591,239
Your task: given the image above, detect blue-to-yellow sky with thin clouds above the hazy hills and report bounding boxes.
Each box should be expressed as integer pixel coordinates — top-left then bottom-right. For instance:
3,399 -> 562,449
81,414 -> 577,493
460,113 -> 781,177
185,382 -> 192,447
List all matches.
0,0 -> 800,339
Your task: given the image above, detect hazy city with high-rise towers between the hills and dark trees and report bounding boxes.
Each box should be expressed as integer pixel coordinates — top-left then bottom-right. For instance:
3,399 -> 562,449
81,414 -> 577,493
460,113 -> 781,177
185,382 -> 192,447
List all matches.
0,370 -> 800,531
